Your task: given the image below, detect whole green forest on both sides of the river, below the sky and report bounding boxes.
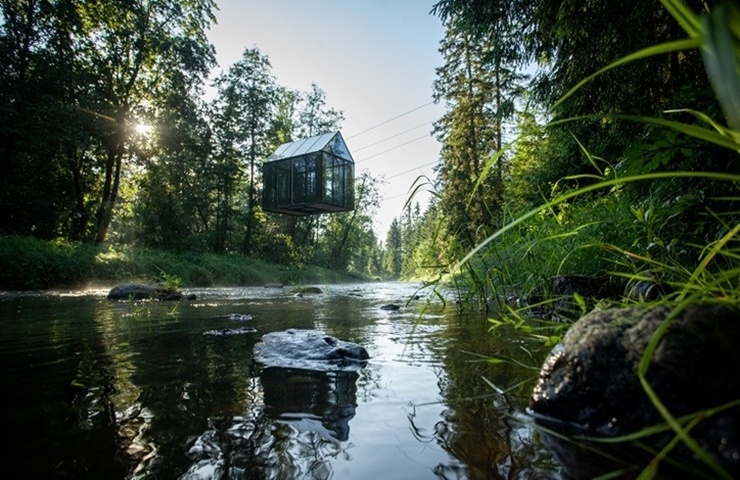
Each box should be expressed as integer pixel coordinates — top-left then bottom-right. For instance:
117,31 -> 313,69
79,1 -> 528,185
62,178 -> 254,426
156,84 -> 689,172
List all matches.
0,0 -> 740,298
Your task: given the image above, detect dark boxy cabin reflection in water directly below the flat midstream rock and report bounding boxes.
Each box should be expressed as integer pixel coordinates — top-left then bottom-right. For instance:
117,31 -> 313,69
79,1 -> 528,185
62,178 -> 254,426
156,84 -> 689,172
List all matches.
260,367 -> 359,441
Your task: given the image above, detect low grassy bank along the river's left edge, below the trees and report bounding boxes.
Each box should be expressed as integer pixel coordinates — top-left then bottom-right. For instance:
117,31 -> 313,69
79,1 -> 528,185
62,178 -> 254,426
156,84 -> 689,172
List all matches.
0,236 -> 367,290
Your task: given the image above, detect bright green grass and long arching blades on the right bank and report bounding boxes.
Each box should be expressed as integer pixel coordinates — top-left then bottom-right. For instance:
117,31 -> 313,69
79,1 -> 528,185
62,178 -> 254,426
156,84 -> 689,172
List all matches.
416,0 -> 740,479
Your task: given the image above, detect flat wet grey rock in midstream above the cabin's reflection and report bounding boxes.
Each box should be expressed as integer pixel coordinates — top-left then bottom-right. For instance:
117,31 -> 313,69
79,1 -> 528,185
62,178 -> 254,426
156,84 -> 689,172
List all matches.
254,329 -> 370,372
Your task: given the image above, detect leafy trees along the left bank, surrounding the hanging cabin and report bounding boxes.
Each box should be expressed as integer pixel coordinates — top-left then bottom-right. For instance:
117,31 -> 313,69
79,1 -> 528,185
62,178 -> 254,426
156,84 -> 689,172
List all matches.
0,0 -> 377,282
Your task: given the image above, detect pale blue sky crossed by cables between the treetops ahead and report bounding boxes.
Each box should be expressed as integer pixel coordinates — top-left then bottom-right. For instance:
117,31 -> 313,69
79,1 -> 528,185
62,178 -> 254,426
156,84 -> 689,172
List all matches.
209,0 -> 444,241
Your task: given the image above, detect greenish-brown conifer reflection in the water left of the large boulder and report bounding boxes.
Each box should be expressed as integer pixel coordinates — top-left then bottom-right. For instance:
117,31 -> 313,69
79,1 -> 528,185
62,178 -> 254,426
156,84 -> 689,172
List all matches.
409,318 -> 554,479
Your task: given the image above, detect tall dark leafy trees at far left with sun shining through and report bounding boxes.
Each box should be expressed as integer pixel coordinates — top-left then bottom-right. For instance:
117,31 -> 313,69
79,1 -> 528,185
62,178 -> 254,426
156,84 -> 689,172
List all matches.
0,0 -> 214,243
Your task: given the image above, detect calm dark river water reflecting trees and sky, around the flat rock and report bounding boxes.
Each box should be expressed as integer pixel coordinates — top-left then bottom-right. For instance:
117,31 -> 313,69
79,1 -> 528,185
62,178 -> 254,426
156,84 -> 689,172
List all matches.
0,283 -> 561,480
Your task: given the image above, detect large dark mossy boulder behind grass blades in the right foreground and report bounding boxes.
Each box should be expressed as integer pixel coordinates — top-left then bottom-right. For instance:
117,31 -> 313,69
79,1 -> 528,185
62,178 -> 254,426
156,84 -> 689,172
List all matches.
529,304 -> 740,478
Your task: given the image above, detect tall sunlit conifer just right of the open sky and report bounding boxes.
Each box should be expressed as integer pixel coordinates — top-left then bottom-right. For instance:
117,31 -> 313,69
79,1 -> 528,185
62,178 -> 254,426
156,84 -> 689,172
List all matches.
434,7 -> 522,248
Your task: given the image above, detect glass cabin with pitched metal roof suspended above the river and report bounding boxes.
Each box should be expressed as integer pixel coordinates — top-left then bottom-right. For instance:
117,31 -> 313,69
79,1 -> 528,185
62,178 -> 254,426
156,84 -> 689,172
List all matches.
262,132 -> 355,216
